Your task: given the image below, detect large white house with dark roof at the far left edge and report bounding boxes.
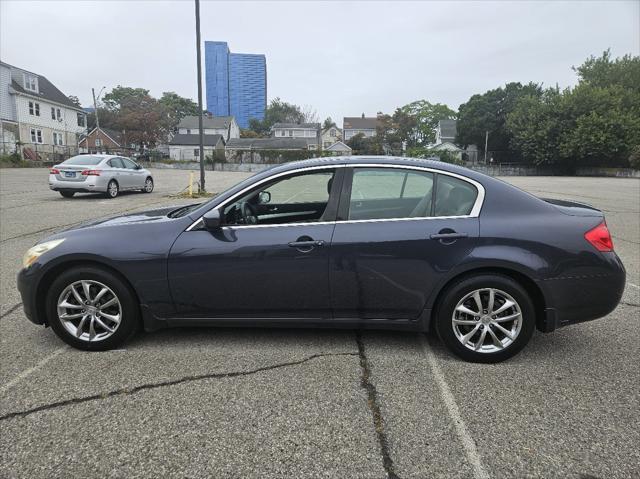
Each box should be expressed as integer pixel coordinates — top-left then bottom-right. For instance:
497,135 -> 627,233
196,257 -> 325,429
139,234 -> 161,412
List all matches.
0,62 -> 87,161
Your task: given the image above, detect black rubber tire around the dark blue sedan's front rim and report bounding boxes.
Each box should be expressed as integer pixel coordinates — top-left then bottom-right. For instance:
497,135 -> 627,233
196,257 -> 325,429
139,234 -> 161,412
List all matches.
45,266 -> 140,351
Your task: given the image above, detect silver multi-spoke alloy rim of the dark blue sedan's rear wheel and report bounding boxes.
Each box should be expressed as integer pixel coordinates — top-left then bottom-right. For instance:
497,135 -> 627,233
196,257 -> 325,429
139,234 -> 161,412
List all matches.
451,288 -> 522,353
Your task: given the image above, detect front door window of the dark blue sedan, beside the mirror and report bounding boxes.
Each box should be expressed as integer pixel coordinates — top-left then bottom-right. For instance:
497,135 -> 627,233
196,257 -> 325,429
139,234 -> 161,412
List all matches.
223,169 -> 335,225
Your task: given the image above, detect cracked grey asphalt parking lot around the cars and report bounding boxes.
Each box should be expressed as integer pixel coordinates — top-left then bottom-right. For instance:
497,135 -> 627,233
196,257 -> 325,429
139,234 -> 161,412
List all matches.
0,169 -> 640,479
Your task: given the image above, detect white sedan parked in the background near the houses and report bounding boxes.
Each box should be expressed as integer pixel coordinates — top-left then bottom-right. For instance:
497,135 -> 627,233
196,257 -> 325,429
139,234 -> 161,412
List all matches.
49,154 -> 153,198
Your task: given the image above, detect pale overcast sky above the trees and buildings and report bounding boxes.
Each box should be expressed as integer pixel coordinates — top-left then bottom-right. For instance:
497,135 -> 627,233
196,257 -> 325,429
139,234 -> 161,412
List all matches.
0,0 -> 640,124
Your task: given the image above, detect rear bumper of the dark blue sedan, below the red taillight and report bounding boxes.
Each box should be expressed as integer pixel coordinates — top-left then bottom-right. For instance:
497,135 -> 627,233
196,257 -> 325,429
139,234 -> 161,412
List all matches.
540,253 -> 626,332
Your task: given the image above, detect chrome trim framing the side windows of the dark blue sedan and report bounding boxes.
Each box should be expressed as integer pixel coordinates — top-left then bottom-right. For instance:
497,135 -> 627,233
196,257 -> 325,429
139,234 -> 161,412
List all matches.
185,163 -> 485,231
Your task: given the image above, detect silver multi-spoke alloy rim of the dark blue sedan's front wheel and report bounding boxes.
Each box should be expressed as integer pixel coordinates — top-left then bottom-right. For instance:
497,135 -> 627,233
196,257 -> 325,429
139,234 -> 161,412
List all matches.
57,280 -> 122,342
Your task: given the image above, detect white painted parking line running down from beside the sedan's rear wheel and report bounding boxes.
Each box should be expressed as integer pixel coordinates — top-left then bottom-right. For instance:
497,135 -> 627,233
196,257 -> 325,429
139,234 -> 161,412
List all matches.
421,335 -> 490,479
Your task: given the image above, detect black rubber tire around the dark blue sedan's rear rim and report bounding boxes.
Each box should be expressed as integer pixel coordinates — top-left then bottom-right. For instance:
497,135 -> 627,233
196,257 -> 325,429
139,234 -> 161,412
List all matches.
435,274 -> 536,363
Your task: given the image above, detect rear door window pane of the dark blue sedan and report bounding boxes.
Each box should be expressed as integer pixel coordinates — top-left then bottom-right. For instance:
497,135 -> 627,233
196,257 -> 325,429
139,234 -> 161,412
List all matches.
348,168 -> 433,220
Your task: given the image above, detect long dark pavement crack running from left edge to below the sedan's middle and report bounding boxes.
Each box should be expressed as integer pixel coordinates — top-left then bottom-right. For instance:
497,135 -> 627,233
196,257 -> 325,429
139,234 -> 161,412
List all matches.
0,353 -> 358,421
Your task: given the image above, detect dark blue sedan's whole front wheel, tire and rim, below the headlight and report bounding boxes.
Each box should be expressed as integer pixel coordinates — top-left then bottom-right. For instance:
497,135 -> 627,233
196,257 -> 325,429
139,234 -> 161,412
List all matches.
46,267 -> 139,351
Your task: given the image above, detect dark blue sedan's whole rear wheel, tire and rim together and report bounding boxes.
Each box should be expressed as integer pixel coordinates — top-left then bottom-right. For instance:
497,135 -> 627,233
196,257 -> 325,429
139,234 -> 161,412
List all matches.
436,274 -> 535,363
